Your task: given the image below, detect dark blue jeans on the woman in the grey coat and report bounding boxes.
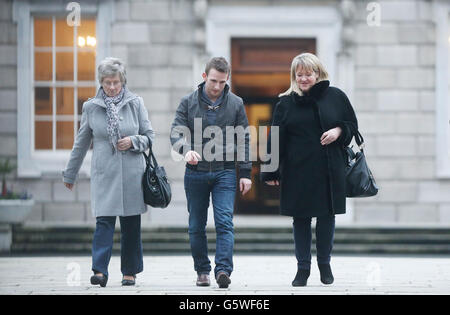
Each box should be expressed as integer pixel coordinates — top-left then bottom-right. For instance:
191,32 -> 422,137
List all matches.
92,215 -> 144,276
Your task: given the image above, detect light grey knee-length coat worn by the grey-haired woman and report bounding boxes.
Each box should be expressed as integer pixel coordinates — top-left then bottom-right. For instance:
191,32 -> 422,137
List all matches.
63,87 -> 154,217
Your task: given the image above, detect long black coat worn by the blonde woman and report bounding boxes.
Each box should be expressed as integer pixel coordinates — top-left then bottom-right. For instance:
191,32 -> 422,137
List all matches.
261,81 -> 358,218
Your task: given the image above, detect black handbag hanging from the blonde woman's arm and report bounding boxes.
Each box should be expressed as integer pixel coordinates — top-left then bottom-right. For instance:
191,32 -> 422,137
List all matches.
345,131 -> 378,198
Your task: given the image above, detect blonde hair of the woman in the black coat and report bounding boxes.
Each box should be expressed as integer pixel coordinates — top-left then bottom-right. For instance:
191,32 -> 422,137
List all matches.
279,53 -> 328,96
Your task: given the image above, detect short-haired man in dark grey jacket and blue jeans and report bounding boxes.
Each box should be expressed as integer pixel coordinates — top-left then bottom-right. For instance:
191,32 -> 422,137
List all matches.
170,57 -> 252,288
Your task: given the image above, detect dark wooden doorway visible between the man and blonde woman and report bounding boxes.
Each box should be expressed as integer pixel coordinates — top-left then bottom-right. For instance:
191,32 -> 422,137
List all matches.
231,38 -> 316,214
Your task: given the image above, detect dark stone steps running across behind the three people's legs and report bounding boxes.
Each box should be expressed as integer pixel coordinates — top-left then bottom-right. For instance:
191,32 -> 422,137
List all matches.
12,226 -> 450,254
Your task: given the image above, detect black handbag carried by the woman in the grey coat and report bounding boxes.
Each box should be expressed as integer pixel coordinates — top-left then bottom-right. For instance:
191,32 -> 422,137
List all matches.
142,139 -> 172,208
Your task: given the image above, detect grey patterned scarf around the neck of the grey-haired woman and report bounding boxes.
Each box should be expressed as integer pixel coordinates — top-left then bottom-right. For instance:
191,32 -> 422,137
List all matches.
102,86 -> 125,154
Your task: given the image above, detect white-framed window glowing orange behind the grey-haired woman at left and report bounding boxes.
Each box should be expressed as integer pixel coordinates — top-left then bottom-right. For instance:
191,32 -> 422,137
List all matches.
13,0 -> 114,178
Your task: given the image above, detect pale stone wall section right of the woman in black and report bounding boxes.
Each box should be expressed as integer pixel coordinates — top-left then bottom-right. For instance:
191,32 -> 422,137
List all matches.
353,0 -> 450,224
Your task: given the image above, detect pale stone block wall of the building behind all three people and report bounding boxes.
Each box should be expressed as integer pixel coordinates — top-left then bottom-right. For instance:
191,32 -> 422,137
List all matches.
0,0 -> 450,225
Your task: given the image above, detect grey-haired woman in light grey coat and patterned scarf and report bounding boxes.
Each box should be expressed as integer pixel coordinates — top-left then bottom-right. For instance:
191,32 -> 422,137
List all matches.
63,58 -> 154,287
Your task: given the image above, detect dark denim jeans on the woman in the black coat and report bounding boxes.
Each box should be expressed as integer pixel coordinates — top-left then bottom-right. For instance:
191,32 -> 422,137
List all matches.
294,215 -> 335,269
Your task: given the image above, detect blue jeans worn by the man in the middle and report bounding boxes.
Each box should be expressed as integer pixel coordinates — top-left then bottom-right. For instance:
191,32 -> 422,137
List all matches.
184,168 -> 236,275
